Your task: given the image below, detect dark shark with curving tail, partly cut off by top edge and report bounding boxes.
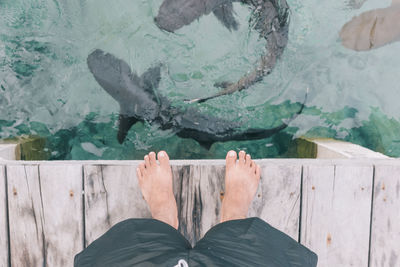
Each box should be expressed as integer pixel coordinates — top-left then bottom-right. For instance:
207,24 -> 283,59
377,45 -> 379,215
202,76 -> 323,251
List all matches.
154,0 -> 290,103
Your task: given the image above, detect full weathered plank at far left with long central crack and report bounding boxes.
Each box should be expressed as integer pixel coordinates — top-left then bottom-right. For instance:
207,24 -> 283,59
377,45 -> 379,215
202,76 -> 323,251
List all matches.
7,165 -> 83,266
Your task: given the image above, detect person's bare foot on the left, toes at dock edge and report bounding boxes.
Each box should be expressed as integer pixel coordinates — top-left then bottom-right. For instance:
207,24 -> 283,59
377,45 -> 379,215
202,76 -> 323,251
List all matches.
136,151 -> 179,229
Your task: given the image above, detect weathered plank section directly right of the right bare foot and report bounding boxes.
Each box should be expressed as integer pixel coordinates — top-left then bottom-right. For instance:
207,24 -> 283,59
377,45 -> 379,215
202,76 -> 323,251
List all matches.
249,163 -> 302,240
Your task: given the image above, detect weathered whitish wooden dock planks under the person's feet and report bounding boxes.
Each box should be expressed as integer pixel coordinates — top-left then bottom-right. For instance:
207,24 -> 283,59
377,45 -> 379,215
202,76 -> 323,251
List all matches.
0,159 -> 400,267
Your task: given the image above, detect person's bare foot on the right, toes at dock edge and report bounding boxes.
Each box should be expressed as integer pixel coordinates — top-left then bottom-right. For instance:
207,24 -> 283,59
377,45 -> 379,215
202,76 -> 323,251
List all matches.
221,151 -> 260,222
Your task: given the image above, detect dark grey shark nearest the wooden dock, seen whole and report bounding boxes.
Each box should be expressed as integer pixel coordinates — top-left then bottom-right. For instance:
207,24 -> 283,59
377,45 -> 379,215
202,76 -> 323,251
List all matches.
87,49 -> 304,149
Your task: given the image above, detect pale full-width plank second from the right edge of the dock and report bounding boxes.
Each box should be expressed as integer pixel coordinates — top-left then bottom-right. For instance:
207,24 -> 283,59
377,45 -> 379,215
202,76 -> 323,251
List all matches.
301,165 -> 373,267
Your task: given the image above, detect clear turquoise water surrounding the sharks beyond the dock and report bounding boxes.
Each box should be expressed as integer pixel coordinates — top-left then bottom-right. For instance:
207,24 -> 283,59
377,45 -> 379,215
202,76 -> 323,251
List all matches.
0,0 -> 400,159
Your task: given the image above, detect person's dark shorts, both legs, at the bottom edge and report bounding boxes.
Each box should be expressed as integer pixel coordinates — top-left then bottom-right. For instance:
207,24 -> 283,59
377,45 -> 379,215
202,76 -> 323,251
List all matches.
74,218 -> 317,267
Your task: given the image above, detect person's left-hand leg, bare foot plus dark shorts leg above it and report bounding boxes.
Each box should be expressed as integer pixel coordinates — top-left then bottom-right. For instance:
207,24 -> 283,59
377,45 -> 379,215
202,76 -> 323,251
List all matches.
74,151 -> 191,267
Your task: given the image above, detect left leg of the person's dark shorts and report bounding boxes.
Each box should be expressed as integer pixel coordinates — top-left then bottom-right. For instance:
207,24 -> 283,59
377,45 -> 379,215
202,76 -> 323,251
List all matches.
74,219 -> 191,267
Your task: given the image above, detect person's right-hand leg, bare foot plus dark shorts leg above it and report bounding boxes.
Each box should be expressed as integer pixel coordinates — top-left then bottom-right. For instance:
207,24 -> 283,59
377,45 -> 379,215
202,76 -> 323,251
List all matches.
189,151 -> 317,267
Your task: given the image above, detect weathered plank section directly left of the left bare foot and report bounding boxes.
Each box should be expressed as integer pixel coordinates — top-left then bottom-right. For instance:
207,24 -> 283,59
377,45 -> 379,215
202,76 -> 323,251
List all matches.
84,165 -> 151,245
